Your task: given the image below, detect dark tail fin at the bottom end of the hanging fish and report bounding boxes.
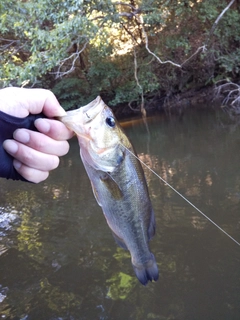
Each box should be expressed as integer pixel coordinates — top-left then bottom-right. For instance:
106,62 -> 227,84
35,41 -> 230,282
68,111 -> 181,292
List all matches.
133,254 -> 159,286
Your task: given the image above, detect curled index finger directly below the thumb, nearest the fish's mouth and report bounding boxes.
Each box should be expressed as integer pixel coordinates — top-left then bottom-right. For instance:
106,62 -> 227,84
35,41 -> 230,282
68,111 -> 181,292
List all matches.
34,118 -> 74,140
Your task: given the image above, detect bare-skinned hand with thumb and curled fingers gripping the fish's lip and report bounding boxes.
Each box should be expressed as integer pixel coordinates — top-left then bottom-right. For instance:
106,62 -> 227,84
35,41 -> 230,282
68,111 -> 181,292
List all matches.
0,87 -> 73,183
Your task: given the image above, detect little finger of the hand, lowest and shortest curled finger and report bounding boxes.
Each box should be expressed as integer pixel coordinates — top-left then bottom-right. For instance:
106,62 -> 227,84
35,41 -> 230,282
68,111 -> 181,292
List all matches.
13,160 -> 49,183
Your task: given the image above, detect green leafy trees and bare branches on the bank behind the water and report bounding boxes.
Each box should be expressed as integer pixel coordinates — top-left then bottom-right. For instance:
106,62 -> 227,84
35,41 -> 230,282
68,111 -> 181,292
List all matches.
0,0 -> 240,109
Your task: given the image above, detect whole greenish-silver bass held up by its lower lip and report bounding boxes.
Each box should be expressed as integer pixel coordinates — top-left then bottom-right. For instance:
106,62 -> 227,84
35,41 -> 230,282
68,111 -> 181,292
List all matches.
59,96 -> 159,285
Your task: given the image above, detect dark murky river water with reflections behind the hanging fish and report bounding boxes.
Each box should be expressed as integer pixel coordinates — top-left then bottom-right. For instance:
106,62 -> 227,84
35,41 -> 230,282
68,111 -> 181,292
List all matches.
0,109 -> 240,320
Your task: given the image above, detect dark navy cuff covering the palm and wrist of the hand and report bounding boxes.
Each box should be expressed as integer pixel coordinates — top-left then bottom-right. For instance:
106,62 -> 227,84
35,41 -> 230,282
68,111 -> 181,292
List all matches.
0,111 -> 46,181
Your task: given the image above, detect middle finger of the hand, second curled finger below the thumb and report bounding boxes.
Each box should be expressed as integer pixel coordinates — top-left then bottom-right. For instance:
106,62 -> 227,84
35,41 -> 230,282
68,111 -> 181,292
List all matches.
13,129 -> 69,156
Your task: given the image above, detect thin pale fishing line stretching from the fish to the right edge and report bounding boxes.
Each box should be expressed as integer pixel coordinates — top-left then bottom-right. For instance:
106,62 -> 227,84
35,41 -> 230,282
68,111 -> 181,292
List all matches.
121,144 -> 240,246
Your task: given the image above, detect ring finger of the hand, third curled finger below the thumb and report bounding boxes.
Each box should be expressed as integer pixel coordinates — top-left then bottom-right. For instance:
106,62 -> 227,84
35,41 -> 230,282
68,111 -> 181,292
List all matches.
3,140 -> 59,171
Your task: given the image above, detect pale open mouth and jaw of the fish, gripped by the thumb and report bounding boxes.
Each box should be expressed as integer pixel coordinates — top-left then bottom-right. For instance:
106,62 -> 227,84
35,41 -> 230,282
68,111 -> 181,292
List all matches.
58,96 -> 105,140
